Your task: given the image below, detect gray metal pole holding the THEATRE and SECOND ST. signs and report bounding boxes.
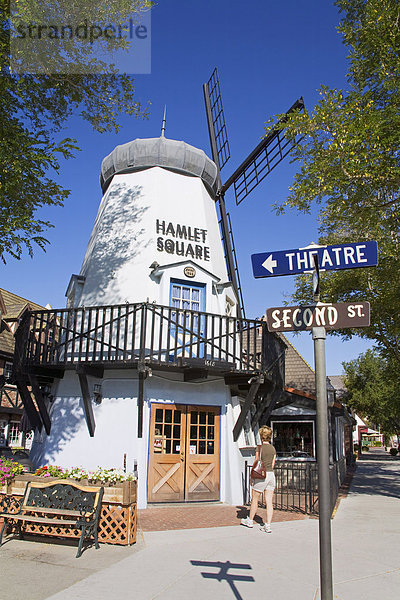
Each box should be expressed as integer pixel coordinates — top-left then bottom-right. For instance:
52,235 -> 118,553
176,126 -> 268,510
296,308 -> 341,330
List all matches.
312,256 -> 333,600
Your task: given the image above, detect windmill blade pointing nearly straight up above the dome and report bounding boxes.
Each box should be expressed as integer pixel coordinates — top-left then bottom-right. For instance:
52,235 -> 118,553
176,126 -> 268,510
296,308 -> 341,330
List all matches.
203,67 -> 231,169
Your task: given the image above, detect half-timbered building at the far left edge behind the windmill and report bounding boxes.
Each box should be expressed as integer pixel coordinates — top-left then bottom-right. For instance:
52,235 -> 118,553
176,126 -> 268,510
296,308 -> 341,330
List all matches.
0,288 -> 43,448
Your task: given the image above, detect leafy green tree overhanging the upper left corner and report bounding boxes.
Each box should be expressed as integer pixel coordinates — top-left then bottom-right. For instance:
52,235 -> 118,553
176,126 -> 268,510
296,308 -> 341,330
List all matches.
0,0 -> 152,262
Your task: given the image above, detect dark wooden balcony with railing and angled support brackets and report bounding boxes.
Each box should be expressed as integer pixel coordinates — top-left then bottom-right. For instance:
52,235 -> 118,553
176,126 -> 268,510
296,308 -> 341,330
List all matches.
13,302 -> 286,440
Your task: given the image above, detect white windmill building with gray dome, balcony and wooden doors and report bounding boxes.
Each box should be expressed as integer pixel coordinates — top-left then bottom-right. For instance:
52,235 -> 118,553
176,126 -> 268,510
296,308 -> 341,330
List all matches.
12,136 -> 285,508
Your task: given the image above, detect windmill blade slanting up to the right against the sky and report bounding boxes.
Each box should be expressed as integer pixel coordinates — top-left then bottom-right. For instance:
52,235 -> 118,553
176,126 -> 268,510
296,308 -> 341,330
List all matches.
221,98 -> 304,204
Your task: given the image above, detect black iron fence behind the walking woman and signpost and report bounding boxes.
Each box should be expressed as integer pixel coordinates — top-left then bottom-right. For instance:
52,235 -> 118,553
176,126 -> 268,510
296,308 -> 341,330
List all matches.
243,458 -> 346,515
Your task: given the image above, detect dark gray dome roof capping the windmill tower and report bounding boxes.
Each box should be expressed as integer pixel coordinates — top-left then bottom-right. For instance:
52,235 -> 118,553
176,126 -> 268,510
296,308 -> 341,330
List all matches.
100,136 -> 217,195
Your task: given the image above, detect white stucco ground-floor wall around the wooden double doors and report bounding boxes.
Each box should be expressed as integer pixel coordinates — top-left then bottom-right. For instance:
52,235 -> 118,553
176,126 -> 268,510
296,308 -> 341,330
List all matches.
31,371 -> 243,508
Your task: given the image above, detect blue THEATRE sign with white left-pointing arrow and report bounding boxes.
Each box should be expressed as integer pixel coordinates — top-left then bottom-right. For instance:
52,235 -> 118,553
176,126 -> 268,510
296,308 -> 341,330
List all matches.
251,241 -> 378,278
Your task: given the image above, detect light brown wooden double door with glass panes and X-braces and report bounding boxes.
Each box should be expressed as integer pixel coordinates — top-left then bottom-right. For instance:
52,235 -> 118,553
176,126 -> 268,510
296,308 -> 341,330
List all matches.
148,403 -> 220,502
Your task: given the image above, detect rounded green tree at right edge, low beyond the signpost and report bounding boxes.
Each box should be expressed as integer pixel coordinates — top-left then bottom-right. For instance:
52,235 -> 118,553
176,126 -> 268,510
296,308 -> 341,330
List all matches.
343,350 -> 400,435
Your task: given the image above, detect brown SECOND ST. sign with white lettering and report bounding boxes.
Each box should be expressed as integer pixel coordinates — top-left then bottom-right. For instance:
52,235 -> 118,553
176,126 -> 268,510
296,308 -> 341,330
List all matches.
267,302 -> 370,331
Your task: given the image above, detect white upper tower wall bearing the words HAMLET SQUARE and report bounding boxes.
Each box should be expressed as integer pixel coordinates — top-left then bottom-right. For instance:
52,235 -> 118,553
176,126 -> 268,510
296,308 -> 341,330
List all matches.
79,167 -> 236,314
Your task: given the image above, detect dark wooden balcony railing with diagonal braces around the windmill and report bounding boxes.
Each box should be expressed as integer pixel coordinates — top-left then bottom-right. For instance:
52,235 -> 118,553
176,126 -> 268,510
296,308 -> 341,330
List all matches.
15,303 -> 284,380
